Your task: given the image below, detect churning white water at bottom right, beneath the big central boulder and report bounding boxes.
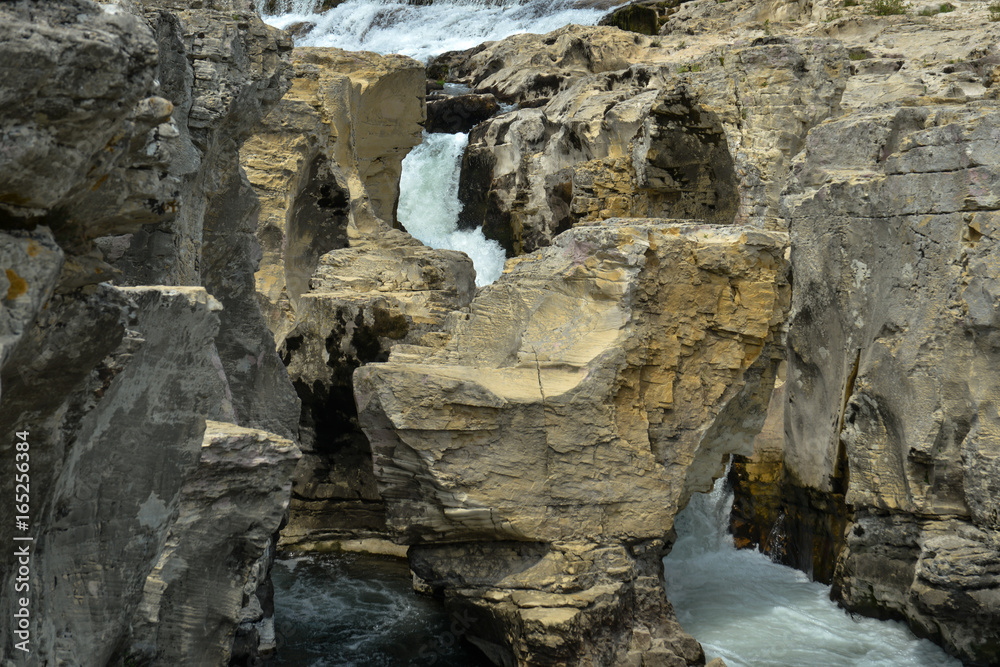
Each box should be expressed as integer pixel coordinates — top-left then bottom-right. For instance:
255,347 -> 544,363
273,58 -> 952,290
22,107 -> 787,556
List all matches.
663,468 -> 961,667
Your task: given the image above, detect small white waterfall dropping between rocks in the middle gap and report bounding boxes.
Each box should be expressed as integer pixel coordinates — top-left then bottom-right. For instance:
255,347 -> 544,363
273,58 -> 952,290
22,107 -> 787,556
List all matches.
397,132 -> 507,287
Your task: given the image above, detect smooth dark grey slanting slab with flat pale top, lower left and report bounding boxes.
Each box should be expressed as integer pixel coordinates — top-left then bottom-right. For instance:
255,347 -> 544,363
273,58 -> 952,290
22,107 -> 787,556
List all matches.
0,288 -> 226,665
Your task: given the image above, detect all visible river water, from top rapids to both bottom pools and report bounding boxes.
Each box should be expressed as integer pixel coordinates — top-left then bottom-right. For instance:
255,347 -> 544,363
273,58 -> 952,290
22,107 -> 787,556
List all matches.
258,0 -> 960,667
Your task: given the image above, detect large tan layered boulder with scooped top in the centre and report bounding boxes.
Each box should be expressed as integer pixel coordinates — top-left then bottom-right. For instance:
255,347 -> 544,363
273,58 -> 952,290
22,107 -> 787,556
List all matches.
355,220 -> 789,665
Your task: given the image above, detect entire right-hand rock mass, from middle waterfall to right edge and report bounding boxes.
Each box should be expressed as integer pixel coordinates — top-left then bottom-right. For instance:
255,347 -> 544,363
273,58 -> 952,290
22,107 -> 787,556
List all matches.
420,5 -> 1000,664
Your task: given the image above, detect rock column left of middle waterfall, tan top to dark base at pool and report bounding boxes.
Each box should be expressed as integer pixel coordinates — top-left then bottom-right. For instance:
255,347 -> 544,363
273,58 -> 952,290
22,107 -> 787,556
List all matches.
241,48 -> 475,552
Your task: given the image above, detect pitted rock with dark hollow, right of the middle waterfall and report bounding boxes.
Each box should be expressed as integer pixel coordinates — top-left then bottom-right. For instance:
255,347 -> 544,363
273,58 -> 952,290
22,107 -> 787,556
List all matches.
450,26 -> 849,256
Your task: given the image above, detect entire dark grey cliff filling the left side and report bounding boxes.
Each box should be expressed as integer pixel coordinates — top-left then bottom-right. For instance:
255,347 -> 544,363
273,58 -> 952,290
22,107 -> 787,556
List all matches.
0,0 -> 299,665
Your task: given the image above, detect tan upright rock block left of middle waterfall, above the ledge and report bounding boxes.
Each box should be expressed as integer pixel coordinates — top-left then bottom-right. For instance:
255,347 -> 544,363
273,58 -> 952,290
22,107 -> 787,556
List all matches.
247,48 -> 425,344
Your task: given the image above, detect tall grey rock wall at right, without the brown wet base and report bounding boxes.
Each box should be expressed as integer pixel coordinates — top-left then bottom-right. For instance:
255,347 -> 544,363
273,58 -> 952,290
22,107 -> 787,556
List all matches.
784,106 -> 1000,663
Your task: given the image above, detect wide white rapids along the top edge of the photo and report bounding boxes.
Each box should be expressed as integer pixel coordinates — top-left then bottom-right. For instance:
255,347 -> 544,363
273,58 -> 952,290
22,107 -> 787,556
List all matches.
257,0 -> 607,61
